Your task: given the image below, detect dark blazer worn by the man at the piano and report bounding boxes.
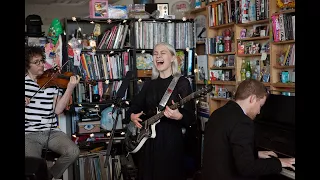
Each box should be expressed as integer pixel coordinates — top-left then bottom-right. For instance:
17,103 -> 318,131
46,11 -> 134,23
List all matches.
202,101 -> 282,180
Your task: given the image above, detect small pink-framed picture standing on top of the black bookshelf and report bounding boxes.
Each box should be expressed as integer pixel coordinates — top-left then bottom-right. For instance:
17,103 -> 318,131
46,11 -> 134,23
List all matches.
89,0 -> 108,18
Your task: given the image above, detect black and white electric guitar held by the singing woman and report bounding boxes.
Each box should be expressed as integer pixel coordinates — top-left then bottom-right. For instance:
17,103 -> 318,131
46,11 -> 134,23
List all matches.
124,85 -> 212,153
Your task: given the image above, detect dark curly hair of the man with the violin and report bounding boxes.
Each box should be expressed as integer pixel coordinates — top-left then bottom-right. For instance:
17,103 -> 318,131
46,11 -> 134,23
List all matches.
24,46 -> 46,74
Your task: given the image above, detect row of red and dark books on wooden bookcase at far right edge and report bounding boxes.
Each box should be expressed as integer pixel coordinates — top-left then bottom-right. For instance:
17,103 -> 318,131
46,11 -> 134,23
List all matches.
271,14 -> 295,42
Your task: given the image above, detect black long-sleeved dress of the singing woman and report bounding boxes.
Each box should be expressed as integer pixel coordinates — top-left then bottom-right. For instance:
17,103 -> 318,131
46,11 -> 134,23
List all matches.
127,76 -> 195,180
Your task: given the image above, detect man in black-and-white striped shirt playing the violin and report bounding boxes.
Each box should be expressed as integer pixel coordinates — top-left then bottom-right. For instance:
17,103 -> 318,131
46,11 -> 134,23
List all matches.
25,47 -> 80,179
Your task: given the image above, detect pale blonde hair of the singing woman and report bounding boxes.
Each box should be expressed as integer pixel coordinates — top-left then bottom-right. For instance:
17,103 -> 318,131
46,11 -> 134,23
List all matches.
151,42 -> 181,79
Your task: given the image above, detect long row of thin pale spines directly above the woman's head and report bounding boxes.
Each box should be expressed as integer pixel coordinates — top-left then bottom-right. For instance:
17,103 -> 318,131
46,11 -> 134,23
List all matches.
135,21 -> 194,49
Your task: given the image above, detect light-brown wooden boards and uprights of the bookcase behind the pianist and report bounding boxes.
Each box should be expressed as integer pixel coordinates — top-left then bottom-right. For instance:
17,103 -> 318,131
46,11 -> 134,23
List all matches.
192,0 -> 295,113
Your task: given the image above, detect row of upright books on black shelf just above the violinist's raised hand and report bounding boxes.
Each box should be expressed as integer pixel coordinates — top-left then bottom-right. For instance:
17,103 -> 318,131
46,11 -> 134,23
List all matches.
78,52 -> 129,80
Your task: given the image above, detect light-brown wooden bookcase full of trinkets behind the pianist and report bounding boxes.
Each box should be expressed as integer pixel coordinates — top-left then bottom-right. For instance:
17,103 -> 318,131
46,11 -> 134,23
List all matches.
189,0 -> 295,114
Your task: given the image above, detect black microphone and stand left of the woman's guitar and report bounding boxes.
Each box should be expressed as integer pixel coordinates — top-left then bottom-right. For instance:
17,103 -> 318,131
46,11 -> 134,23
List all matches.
104,98 -> 122,180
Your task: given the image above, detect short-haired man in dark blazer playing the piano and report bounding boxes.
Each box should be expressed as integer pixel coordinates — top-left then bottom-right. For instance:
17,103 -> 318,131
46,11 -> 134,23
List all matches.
202,79 -> 295,180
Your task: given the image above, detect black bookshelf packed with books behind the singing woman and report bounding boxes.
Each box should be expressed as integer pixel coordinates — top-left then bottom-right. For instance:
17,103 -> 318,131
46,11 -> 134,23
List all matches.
63,18 -> 195,178
